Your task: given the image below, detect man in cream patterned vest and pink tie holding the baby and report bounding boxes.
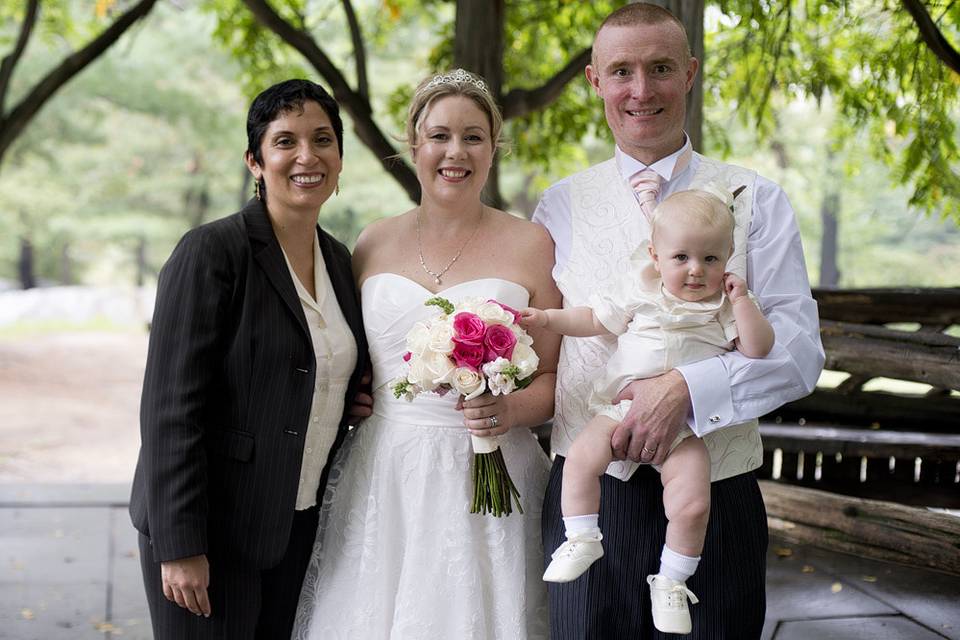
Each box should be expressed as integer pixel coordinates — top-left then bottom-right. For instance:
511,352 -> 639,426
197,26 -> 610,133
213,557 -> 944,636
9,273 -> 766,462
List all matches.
533,3 -> 823,640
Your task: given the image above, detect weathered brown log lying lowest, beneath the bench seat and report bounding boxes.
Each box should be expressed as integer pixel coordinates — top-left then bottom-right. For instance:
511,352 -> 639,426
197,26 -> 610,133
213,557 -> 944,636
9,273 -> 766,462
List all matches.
760,480 -> 960,575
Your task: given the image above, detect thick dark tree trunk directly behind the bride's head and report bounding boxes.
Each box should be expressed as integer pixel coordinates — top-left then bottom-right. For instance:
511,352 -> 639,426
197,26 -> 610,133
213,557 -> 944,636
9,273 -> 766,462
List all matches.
453,0 -> 506,209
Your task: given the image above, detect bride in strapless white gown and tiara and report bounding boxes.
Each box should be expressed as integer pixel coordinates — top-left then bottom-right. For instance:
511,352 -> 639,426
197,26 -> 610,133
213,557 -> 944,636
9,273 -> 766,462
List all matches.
294,69 -> 561,640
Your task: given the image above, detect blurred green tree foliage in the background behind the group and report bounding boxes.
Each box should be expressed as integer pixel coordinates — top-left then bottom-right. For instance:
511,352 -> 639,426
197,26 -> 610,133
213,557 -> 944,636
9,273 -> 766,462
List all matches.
0,0 -> 960,286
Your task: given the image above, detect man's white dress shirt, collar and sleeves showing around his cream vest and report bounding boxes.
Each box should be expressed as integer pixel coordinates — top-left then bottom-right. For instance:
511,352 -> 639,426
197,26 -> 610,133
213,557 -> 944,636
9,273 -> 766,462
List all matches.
533,140 -> 824,437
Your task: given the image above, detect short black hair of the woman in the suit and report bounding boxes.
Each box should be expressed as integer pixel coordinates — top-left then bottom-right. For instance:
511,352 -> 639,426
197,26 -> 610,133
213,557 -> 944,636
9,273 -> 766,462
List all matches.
247,79 -> 343,166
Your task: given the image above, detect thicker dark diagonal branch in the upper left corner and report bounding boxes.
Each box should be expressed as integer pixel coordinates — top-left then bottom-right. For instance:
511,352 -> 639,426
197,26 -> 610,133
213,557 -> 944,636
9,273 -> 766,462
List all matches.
0,0 -> 157,168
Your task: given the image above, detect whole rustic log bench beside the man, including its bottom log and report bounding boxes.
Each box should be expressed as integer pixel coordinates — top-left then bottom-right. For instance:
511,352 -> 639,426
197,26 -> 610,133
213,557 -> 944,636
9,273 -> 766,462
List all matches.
758,288 -> 960,574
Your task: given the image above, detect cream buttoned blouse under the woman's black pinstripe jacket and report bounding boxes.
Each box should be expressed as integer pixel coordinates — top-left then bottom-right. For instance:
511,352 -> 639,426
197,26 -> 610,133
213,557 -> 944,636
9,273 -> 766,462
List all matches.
283,234 -> 357,511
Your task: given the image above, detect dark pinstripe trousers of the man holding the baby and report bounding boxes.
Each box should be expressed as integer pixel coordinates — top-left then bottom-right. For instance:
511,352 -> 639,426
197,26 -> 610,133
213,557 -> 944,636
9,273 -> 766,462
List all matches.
542,456 -> 767,640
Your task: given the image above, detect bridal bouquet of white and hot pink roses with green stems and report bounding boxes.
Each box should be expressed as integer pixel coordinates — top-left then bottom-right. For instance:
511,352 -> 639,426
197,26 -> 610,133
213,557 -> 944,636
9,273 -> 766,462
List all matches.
391,296 -> 540,517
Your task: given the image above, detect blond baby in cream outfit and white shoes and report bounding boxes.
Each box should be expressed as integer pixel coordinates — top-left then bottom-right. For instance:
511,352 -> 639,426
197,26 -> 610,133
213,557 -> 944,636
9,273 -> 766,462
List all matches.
521,185 -> 774,633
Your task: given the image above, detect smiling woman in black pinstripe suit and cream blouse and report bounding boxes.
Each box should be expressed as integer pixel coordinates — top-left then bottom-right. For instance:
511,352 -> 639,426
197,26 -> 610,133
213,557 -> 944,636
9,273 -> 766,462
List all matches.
130,80 -> 366,640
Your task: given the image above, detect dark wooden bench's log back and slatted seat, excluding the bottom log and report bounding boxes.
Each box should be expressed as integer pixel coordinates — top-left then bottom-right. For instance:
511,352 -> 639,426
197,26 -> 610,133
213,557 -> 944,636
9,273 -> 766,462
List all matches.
760,288 -> 960,509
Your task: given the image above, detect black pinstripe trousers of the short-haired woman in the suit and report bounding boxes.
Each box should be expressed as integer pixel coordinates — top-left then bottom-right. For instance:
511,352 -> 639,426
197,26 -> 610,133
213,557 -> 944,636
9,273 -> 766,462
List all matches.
140,507 -> 319,640
